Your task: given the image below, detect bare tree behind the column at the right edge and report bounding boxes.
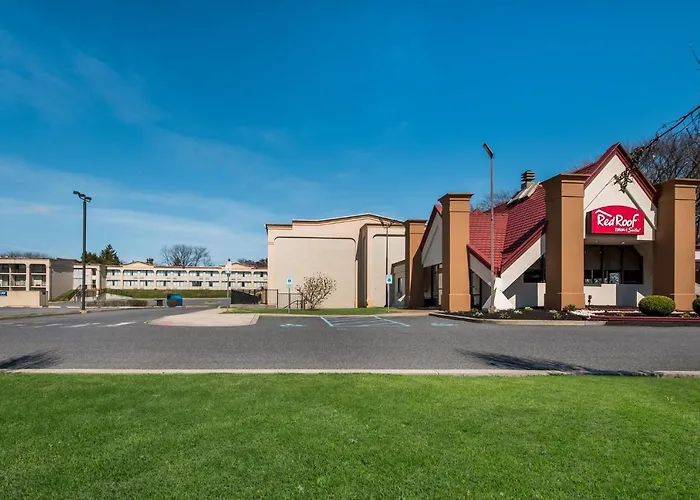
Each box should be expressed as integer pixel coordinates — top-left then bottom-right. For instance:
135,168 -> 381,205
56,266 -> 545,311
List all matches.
630,126 -> 700,243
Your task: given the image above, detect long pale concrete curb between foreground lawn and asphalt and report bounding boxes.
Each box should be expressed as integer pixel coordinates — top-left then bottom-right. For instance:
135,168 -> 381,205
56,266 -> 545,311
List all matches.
0,368 -> 700,378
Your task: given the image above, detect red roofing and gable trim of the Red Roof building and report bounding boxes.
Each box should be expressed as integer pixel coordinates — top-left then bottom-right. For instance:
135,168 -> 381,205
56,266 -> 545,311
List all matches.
421,143 -> 656,274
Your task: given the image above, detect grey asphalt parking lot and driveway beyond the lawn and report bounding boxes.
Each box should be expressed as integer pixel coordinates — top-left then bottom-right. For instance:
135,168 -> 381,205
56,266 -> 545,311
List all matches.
0,309 -> 700,373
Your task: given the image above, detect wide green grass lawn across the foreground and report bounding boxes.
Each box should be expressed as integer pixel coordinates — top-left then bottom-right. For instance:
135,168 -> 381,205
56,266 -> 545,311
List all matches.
0,374 -> 700,499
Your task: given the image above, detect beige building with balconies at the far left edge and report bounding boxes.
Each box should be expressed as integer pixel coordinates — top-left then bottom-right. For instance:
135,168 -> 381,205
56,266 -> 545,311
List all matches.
0,257 -> 73,307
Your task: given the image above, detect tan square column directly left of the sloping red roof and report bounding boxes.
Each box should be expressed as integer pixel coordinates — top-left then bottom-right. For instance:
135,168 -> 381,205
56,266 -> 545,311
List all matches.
440,193 -> 472,311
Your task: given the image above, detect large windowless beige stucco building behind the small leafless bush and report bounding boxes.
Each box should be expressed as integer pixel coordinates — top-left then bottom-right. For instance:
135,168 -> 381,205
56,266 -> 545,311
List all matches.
265,214 -> 405,307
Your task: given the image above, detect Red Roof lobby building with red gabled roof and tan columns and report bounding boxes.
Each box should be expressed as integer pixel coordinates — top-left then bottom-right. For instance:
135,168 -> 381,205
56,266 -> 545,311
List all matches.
401,144 -> 700,310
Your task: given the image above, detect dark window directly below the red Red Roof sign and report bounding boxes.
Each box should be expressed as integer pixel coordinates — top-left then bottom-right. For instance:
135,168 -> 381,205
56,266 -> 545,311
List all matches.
583,245 -> 644,285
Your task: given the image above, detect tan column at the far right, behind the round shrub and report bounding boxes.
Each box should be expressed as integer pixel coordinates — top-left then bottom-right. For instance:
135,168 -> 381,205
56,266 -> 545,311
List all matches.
653,179 -> 700,311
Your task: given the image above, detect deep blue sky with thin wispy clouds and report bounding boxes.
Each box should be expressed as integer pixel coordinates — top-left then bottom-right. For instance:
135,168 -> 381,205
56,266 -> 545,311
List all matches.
0,0 -> 700,262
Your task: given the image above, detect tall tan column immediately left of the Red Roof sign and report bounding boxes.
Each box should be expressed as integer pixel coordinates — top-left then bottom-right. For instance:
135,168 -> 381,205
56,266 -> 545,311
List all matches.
543,174 -> 588,311
